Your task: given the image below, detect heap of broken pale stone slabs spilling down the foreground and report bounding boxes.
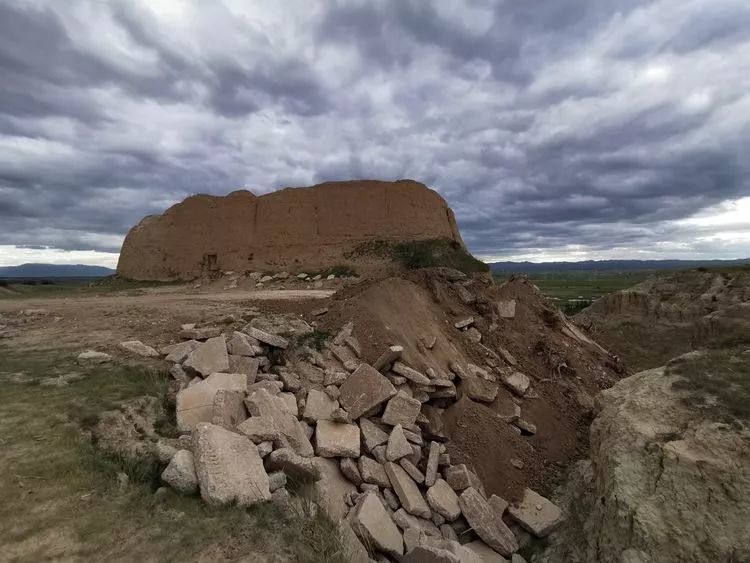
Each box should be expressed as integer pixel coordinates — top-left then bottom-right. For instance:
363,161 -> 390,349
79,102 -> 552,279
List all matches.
117,290 -> 562,561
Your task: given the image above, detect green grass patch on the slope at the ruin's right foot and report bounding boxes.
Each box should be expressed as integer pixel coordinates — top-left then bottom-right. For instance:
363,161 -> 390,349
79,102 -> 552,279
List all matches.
353,239 -> 489,274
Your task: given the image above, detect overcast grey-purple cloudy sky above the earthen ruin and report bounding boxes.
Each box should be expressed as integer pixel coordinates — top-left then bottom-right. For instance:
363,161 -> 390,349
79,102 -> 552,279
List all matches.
0,0 -> 750,266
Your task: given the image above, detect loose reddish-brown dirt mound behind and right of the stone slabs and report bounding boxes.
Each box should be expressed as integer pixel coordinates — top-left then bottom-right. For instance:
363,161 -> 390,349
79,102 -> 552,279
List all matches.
312,269 -> 622,499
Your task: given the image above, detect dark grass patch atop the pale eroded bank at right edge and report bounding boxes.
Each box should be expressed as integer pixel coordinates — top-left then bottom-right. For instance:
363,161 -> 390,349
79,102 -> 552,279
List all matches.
666,346 -> 750,423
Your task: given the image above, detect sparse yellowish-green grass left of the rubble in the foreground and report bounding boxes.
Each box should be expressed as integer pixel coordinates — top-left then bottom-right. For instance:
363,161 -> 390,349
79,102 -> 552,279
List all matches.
0,348 -> 345,562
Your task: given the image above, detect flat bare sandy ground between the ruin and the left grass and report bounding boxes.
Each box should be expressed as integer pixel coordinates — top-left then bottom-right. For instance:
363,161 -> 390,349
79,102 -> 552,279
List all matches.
0,287 -> 335,350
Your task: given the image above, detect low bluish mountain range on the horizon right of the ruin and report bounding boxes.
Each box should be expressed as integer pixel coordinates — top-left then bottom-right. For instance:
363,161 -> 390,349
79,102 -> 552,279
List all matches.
489,258 -> 750,273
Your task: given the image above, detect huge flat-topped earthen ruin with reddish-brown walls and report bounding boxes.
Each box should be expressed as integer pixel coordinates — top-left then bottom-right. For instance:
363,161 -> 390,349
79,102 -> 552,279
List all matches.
117,180 -> 463,280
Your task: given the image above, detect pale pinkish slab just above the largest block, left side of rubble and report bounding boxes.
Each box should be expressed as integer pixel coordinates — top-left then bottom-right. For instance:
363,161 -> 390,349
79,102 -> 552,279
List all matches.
176,373 -> 247,431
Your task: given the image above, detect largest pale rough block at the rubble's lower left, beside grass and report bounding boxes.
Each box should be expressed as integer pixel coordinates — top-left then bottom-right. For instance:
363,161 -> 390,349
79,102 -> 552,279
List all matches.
193,422 -> 271,506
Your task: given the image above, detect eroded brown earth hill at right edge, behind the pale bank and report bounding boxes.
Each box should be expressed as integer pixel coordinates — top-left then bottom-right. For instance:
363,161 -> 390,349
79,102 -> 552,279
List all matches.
576,268 -> 750,370
